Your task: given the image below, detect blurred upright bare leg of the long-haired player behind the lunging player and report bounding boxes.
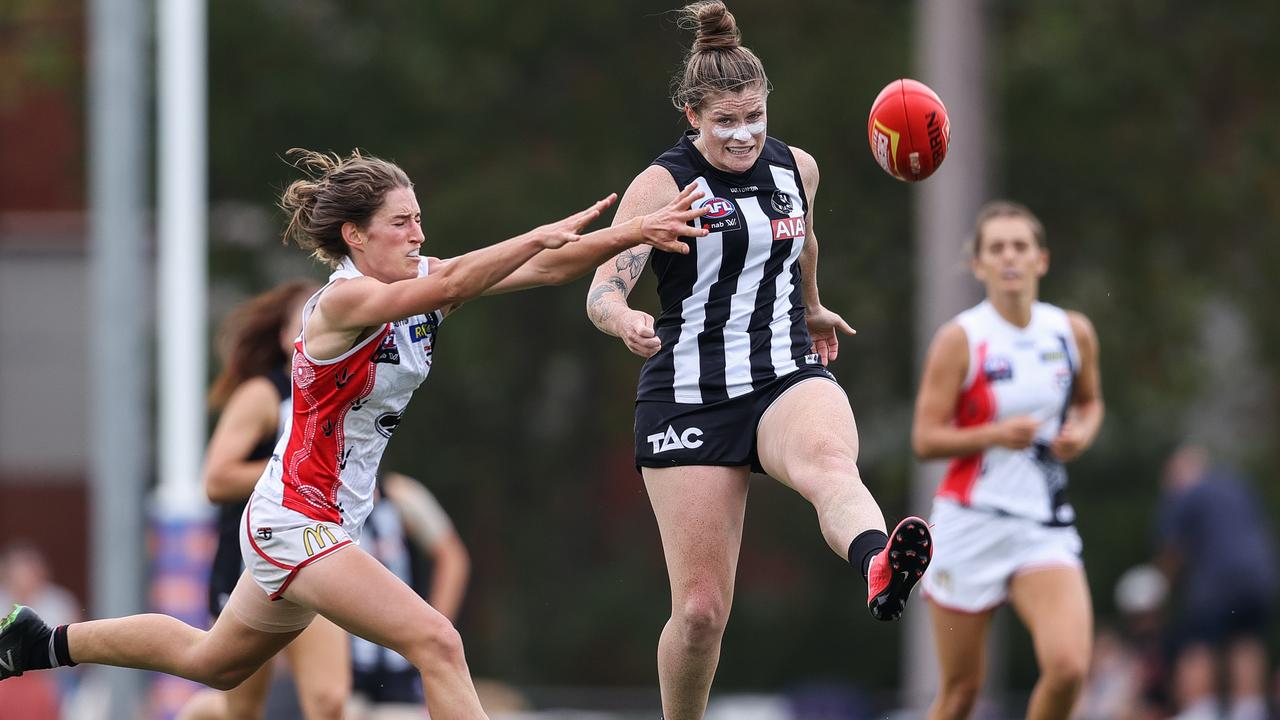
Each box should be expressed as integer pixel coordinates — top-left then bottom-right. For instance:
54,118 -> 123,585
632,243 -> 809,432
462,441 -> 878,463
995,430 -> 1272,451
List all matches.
285,609 -> 351,720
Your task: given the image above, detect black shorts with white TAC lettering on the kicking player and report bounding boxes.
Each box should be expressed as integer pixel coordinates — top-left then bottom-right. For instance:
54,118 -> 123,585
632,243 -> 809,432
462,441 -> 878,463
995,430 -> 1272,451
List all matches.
635,365 -> 836,473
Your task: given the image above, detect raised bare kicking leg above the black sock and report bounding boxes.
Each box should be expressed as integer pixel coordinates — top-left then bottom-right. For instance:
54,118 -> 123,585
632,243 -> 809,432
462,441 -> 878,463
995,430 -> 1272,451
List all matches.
756,378 -> 884,560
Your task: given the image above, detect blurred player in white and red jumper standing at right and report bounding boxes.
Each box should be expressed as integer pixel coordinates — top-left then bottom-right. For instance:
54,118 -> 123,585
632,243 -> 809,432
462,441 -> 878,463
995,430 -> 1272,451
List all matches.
911,201 -> 1103,720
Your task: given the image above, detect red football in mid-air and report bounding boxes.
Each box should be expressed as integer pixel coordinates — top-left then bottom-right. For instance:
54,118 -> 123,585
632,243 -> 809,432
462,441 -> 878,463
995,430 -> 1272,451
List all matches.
867,78 -> 951,182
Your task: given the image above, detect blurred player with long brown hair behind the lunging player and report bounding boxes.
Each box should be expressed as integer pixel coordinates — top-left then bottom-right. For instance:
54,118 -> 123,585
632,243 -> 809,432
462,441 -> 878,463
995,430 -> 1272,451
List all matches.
178,275 -> 351,720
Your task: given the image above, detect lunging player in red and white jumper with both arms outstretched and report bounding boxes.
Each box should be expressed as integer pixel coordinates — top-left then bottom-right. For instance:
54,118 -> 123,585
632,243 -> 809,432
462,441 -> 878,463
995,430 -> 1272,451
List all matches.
0,151 -> 703,720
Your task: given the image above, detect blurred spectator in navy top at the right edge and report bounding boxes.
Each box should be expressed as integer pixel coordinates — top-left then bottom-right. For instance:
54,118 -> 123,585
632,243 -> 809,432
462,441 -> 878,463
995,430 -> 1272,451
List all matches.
1158,445 -> 1277,720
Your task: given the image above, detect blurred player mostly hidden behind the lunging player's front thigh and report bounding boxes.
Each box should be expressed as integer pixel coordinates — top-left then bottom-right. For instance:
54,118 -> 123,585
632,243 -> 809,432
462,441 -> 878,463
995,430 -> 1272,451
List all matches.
348,473 -> 471,720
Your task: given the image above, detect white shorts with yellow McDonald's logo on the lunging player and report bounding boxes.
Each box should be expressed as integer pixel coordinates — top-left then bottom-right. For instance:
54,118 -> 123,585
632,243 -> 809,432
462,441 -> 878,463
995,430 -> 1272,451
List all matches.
241,492 -> 355,601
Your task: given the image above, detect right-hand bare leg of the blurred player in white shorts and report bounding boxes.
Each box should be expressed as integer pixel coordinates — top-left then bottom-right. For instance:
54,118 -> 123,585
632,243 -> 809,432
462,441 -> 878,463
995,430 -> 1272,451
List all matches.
1009,568 -> 1093,720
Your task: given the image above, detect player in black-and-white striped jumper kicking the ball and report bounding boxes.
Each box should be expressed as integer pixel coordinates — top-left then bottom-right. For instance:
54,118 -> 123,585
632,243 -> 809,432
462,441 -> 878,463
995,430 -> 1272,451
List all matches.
586,1 -> 931,720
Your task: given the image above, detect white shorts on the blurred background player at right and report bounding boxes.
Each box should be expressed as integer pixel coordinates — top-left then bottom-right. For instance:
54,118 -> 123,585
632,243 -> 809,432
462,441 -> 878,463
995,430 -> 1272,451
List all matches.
920,500 -> 1083,612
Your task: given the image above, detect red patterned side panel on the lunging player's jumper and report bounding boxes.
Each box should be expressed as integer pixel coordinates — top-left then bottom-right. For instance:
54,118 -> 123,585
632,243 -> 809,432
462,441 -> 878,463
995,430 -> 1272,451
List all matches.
280,323 -> 392,524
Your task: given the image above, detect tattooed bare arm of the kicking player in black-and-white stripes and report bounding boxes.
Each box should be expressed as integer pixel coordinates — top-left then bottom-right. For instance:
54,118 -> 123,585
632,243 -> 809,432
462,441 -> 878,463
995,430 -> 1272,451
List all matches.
586,165 -> 686,357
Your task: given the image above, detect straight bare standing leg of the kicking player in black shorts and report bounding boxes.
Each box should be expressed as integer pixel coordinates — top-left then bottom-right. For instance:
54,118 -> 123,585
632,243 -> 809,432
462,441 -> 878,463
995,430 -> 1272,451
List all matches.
644,466 -> 748,720
